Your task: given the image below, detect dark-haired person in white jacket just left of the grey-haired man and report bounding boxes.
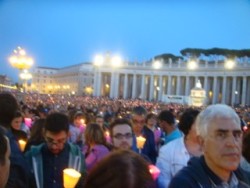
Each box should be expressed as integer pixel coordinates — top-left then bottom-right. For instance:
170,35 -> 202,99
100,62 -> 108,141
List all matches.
156,108 -> 202,188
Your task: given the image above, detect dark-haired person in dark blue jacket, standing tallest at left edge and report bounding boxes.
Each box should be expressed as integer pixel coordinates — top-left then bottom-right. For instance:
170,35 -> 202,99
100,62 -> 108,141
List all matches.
0,92 -> 30,188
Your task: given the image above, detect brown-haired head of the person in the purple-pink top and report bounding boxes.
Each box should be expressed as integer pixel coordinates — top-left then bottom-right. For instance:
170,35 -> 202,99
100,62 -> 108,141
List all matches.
84,123 -> 106,146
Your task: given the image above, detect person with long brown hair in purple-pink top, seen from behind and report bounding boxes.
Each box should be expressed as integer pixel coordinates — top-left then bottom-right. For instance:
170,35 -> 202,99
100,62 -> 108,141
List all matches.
83,123 -> 109,171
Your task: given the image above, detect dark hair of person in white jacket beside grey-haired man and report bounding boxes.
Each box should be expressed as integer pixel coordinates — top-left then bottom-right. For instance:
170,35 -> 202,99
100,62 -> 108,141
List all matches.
178,108 -> 200,136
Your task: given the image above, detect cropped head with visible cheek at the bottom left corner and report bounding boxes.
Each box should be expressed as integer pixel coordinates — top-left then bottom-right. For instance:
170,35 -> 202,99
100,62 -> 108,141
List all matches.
0,131 -> 10,188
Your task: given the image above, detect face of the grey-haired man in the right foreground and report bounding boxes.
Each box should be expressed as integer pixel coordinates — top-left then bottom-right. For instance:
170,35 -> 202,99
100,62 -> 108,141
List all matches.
203,118 -> 242,176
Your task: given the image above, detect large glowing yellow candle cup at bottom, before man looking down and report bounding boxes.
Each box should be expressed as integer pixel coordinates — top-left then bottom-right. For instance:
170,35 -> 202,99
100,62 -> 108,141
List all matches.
63,168 -> 81,188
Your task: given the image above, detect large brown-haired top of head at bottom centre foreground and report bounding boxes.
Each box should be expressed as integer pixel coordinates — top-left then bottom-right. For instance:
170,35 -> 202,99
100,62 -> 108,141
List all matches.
84,150 -> 155,188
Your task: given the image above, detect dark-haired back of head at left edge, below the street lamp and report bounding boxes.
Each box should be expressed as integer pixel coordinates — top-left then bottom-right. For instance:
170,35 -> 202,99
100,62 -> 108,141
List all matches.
0,92 -> 19,128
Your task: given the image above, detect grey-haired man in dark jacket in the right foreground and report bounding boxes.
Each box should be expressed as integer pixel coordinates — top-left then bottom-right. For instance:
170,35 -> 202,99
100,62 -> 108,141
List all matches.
169,104 -> 249,188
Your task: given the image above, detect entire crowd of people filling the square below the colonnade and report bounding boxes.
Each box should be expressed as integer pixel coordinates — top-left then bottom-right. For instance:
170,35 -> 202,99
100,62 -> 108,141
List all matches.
0,92 -> 250,188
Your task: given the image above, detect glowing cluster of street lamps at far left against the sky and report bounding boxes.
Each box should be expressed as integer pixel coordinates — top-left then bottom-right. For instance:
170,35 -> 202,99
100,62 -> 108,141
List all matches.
9,46 -> 34,91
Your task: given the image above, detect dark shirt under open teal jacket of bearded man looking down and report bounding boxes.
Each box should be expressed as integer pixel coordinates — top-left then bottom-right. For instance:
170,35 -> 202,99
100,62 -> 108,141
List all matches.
42,143 -> 69,188
